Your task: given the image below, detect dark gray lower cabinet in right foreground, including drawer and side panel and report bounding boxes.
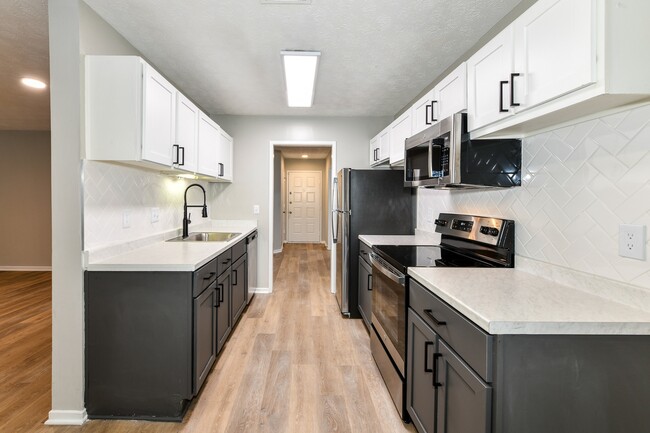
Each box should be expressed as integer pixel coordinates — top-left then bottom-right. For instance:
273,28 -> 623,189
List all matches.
406,280 -> 650,433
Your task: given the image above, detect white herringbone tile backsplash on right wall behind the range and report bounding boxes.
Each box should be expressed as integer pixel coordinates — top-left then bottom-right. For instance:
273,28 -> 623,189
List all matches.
418,105 -> 650,288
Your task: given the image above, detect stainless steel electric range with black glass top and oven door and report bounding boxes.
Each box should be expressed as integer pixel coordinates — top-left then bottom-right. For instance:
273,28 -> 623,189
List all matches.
370,213 -> 515,421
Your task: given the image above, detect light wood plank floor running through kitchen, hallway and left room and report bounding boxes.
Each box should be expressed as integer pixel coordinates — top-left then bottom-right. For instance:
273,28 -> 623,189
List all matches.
0,244 -> 415,433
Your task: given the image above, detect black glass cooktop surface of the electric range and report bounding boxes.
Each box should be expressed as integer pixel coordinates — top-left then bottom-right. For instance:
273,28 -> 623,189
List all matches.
373,245 -> 494,274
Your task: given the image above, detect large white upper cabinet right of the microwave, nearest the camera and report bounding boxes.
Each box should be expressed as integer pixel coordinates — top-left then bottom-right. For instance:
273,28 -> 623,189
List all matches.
467,0 -> 650,138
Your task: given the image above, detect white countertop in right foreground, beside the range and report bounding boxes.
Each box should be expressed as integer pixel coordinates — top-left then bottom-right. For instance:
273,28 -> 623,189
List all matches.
408,268 -> 650,335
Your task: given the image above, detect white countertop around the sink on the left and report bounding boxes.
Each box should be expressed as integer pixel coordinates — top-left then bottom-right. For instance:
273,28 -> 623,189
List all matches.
86,222 -> 257,272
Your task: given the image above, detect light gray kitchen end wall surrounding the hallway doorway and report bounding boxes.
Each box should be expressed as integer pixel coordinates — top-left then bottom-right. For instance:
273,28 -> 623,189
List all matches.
213,116 -> 391,288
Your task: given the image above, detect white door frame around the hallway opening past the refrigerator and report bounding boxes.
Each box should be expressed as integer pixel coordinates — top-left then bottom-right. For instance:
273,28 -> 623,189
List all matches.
268,140 -> 337,293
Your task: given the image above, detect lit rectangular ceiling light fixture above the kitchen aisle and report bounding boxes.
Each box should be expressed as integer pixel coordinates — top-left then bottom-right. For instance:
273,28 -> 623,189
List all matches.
280,51 -> 320,107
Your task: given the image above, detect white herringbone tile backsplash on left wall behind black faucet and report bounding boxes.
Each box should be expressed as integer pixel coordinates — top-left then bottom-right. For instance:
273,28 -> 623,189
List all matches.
84,161 -> 210,250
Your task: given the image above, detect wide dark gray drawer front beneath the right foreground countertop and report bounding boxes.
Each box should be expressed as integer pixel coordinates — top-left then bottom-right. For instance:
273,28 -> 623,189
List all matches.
409,279 -> 494,382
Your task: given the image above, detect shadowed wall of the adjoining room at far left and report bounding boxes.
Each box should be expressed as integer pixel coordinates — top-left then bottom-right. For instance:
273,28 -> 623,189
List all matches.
0,131 -> 52,270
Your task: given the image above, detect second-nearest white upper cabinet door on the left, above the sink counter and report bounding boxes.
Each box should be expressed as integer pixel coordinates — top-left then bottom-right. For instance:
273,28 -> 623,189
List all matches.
172,93 -> 199,172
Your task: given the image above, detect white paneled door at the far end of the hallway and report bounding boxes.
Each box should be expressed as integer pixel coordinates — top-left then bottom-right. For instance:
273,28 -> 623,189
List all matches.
287,171 -> 323,243
